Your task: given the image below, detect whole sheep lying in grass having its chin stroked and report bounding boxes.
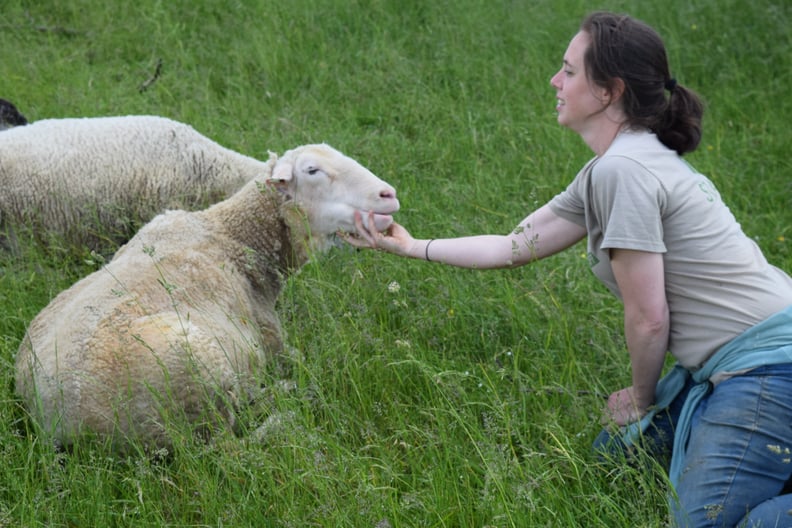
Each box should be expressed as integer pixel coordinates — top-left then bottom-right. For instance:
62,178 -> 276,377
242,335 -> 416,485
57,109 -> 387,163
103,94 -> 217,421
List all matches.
15,144 -> 399,452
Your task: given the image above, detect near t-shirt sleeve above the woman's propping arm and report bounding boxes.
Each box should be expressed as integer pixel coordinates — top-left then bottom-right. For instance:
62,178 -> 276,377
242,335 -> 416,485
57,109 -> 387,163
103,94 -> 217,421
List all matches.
589,156 -> 666,253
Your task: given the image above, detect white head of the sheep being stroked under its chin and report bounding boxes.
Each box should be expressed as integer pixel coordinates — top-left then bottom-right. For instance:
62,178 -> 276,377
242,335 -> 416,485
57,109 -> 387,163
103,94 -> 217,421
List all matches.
270,144 -> 399,245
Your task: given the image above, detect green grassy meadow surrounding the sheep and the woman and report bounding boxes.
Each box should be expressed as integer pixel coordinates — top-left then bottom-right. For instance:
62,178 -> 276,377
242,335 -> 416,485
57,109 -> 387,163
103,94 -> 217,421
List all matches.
0,0 -> 792,528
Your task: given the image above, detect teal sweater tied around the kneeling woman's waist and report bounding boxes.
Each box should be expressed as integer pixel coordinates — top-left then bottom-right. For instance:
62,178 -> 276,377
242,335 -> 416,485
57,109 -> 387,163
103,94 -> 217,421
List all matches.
621,306 -> 792,488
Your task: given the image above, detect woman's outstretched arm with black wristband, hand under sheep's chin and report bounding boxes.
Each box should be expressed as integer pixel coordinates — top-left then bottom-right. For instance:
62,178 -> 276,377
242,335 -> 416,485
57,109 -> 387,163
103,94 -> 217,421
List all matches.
347,205 -> 586,269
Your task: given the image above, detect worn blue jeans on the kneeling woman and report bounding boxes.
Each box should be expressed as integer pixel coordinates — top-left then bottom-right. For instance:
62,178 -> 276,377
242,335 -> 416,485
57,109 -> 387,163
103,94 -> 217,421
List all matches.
594,364 -> 792,528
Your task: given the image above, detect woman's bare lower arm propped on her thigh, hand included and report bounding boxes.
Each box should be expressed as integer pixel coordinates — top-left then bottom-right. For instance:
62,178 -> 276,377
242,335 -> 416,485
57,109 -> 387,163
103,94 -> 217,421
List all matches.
608,249 -> 670,425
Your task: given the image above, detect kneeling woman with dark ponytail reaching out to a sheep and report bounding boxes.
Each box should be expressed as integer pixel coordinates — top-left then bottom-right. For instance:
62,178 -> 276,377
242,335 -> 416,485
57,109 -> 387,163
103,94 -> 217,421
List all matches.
348,9 -> 792,527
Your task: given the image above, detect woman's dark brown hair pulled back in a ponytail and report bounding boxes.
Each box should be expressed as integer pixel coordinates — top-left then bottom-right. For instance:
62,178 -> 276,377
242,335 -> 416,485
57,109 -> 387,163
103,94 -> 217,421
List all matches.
580,12 -> 704,155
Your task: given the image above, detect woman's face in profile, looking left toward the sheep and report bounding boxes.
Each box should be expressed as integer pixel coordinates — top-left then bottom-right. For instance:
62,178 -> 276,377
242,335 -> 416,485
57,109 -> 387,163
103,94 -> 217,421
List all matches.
550,31 -> 609,134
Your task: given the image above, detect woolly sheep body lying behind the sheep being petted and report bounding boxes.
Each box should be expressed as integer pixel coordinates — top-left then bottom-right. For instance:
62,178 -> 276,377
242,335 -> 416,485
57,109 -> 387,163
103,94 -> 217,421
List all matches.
0,116 -> 265,250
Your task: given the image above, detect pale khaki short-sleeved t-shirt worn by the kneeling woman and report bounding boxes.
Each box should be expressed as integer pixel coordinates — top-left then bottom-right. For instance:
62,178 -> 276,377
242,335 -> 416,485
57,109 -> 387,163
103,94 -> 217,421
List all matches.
550,132 -> 792,368
